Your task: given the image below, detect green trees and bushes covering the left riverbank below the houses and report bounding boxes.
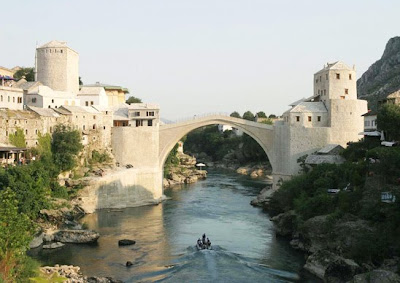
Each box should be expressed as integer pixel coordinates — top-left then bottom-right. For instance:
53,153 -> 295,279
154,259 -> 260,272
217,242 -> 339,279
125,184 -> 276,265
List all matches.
0,125 -> 112,282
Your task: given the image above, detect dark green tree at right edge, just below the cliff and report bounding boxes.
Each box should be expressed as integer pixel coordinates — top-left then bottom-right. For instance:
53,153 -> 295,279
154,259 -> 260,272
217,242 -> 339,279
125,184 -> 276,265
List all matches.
377,104 -> 400,140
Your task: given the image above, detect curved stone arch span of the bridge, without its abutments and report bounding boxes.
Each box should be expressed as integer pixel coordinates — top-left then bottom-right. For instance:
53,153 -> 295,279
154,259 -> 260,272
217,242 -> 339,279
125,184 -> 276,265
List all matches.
159,115 -> 275,173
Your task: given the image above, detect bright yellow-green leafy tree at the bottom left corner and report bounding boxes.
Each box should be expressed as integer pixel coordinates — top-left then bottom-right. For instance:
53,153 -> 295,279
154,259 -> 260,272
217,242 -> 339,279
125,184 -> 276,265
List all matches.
0,188 -> 33,282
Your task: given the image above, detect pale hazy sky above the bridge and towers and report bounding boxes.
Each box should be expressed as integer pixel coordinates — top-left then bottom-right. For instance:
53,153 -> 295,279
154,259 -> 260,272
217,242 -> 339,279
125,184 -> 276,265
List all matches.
0,0 -> 400,120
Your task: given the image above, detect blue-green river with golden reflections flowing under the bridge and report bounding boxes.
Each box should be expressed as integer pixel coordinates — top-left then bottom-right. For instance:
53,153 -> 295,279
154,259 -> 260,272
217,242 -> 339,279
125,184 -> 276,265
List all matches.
30,171 -> 319,282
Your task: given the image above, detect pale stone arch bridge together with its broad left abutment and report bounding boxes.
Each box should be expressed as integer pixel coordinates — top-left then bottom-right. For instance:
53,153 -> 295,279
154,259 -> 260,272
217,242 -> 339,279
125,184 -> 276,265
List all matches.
108,115 -> 304,208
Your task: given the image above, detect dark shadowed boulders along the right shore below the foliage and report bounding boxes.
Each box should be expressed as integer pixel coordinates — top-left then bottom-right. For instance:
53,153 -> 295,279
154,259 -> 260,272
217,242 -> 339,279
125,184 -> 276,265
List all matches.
271,210 -> 400,283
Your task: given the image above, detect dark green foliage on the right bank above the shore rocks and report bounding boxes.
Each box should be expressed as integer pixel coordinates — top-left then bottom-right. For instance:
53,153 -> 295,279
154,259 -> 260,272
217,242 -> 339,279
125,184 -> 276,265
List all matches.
270,140 -> 400,262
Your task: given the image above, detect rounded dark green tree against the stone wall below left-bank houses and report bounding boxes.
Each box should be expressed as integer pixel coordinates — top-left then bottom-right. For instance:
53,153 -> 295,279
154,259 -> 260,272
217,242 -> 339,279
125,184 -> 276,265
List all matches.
51,125 -> 83,172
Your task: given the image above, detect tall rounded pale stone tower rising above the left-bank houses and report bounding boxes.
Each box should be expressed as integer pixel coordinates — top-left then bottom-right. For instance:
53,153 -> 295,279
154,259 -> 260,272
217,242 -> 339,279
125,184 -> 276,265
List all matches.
36,40 -> 79,94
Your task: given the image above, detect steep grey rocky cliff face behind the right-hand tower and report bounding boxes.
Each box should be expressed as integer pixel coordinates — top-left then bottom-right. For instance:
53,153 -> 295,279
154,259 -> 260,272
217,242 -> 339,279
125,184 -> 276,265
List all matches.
357,36 -> 400,110
